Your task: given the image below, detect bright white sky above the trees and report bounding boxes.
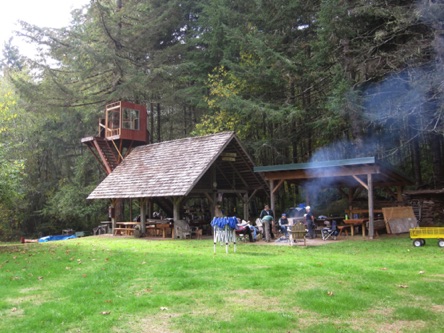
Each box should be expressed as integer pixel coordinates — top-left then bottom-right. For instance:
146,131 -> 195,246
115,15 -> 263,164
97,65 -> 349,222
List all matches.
0,0 -> 89,53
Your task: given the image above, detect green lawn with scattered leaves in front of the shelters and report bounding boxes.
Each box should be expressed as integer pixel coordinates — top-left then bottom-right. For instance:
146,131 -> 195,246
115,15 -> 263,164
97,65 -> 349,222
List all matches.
0,235 -> 444,333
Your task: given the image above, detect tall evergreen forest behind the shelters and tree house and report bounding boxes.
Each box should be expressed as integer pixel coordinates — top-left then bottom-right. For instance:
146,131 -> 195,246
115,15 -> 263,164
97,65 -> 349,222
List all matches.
0,0 -> 444,240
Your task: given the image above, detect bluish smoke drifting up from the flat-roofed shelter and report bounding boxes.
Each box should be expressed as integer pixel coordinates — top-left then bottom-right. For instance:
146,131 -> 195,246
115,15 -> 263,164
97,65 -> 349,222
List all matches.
298,0 -> 444,205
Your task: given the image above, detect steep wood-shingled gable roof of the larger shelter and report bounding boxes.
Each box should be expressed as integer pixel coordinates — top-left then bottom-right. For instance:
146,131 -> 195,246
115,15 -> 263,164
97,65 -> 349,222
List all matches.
88,132 -> 267,199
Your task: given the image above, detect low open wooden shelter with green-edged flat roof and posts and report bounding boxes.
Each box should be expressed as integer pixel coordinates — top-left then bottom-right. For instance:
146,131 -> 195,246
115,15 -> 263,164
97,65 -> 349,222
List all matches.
254,157 -> 412,239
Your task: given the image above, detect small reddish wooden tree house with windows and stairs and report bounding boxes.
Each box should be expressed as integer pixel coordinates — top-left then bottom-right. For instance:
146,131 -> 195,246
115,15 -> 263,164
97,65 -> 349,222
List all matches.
82,101 -> 150,174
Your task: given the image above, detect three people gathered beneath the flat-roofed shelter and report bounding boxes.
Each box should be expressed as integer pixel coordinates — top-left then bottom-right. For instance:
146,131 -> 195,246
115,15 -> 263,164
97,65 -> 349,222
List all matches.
259,205 -> 316,242
